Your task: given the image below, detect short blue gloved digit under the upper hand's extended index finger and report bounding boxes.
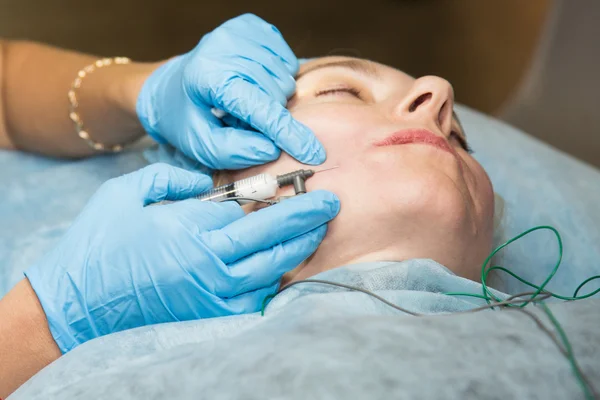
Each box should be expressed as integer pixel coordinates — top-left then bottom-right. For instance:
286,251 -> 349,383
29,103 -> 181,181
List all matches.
201,127 -> 281,170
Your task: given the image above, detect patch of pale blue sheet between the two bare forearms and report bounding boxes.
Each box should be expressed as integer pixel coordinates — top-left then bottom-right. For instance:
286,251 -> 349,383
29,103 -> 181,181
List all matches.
0,151 -> 147,297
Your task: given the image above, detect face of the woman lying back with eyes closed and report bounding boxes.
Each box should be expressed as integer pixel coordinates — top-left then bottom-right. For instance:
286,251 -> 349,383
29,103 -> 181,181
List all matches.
233,57 -> 494,279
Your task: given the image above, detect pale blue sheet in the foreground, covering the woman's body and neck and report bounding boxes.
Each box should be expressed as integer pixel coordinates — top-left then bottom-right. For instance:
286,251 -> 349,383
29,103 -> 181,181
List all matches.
9,260 -> 600,400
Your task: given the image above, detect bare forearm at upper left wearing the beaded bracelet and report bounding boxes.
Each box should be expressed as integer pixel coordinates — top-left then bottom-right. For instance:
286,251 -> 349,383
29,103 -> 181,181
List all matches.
0,41 -> 158,157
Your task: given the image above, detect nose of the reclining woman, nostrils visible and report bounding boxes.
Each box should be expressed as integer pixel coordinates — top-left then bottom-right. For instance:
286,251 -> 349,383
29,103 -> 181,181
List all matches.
395,76 -> 454,136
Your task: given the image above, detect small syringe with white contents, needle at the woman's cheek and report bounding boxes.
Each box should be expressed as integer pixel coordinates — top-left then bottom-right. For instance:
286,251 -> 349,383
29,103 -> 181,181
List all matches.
196,166 -> 337,202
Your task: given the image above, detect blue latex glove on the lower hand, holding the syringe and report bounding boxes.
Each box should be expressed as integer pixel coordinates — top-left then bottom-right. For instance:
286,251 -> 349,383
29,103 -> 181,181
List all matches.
25,164 -> 339,353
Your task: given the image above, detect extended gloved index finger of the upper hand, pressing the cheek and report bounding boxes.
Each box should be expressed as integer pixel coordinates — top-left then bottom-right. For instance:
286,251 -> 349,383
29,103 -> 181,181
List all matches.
215,79 -> 326,165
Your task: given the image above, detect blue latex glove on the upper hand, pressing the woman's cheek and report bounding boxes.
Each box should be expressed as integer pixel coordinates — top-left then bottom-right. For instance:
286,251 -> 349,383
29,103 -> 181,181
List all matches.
137,14 -> 326,170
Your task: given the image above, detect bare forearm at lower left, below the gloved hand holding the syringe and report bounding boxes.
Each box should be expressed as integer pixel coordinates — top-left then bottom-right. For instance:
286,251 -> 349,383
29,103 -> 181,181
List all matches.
0,279 -> 61,398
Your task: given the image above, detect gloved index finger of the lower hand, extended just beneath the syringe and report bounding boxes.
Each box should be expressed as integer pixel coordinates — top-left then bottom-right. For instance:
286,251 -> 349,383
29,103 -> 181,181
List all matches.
200,190 -> 340,264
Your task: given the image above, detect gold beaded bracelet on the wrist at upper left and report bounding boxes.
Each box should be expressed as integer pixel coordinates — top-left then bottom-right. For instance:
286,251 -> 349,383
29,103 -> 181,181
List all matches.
68,57 -> 131,153
